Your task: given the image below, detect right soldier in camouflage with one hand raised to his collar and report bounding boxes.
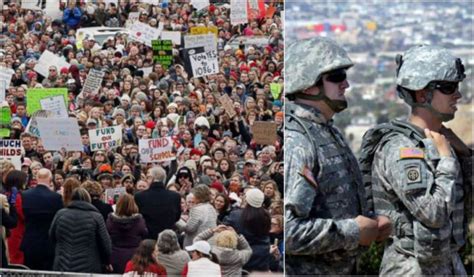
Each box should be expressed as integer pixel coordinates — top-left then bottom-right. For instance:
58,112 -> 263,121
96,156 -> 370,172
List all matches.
361,46 -> 472,276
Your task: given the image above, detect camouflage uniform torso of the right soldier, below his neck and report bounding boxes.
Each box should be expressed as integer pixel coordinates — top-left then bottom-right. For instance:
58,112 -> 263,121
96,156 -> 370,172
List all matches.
366,122 -> 467,275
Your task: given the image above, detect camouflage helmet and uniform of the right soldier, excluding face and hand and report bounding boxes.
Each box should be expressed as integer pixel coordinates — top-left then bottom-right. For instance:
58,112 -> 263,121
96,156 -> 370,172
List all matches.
361,47 -> 472,276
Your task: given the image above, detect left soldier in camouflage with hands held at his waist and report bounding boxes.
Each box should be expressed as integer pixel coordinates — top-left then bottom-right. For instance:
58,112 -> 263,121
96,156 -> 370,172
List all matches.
285,37 -> 391,275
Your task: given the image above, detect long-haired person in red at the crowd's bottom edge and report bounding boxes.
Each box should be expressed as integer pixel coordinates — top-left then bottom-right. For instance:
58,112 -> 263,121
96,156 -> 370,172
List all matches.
123,239 -> 166,277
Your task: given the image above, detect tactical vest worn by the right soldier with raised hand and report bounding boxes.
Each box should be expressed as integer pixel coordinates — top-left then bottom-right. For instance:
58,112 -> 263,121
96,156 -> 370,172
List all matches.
359,120 -> 466,262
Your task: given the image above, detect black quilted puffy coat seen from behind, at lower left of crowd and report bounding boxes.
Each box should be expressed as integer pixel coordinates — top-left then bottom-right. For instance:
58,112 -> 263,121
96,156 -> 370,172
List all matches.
49,201 -> 112,273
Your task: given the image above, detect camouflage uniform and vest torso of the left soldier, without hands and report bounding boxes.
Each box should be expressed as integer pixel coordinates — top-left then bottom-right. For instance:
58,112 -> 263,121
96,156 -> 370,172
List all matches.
285,101 -> 367,275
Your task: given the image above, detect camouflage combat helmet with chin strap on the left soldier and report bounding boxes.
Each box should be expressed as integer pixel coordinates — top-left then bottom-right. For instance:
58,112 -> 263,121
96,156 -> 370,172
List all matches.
285,37 -> 354,112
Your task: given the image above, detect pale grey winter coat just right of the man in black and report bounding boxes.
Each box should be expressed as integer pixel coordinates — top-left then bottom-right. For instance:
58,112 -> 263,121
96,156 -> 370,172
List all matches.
176,203 -> 217,247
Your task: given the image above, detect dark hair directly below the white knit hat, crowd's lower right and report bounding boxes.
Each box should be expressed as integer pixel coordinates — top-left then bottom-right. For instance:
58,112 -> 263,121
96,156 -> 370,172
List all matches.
240,205 -> 272,236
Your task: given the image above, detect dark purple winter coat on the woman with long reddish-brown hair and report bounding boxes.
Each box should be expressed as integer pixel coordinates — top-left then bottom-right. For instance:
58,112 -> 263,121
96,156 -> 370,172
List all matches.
106,213 -> 148,274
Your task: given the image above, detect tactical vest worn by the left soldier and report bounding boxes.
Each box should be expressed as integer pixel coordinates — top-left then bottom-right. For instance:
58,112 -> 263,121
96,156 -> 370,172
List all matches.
285,110 -> 367,219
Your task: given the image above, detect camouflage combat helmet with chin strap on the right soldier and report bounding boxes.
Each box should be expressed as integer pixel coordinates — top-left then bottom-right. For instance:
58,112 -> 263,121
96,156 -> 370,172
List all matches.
396,45 -> 466,121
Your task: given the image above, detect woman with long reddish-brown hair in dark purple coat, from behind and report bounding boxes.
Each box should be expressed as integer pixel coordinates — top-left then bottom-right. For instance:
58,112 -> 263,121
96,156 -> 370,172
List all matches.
106,193 -> 148,274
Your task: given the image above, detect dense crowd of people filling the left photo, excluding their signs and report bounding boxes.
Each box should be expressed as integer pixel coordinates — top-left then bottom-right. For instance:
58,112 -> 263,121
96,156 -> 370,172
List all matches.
0,0 -> 284,276
